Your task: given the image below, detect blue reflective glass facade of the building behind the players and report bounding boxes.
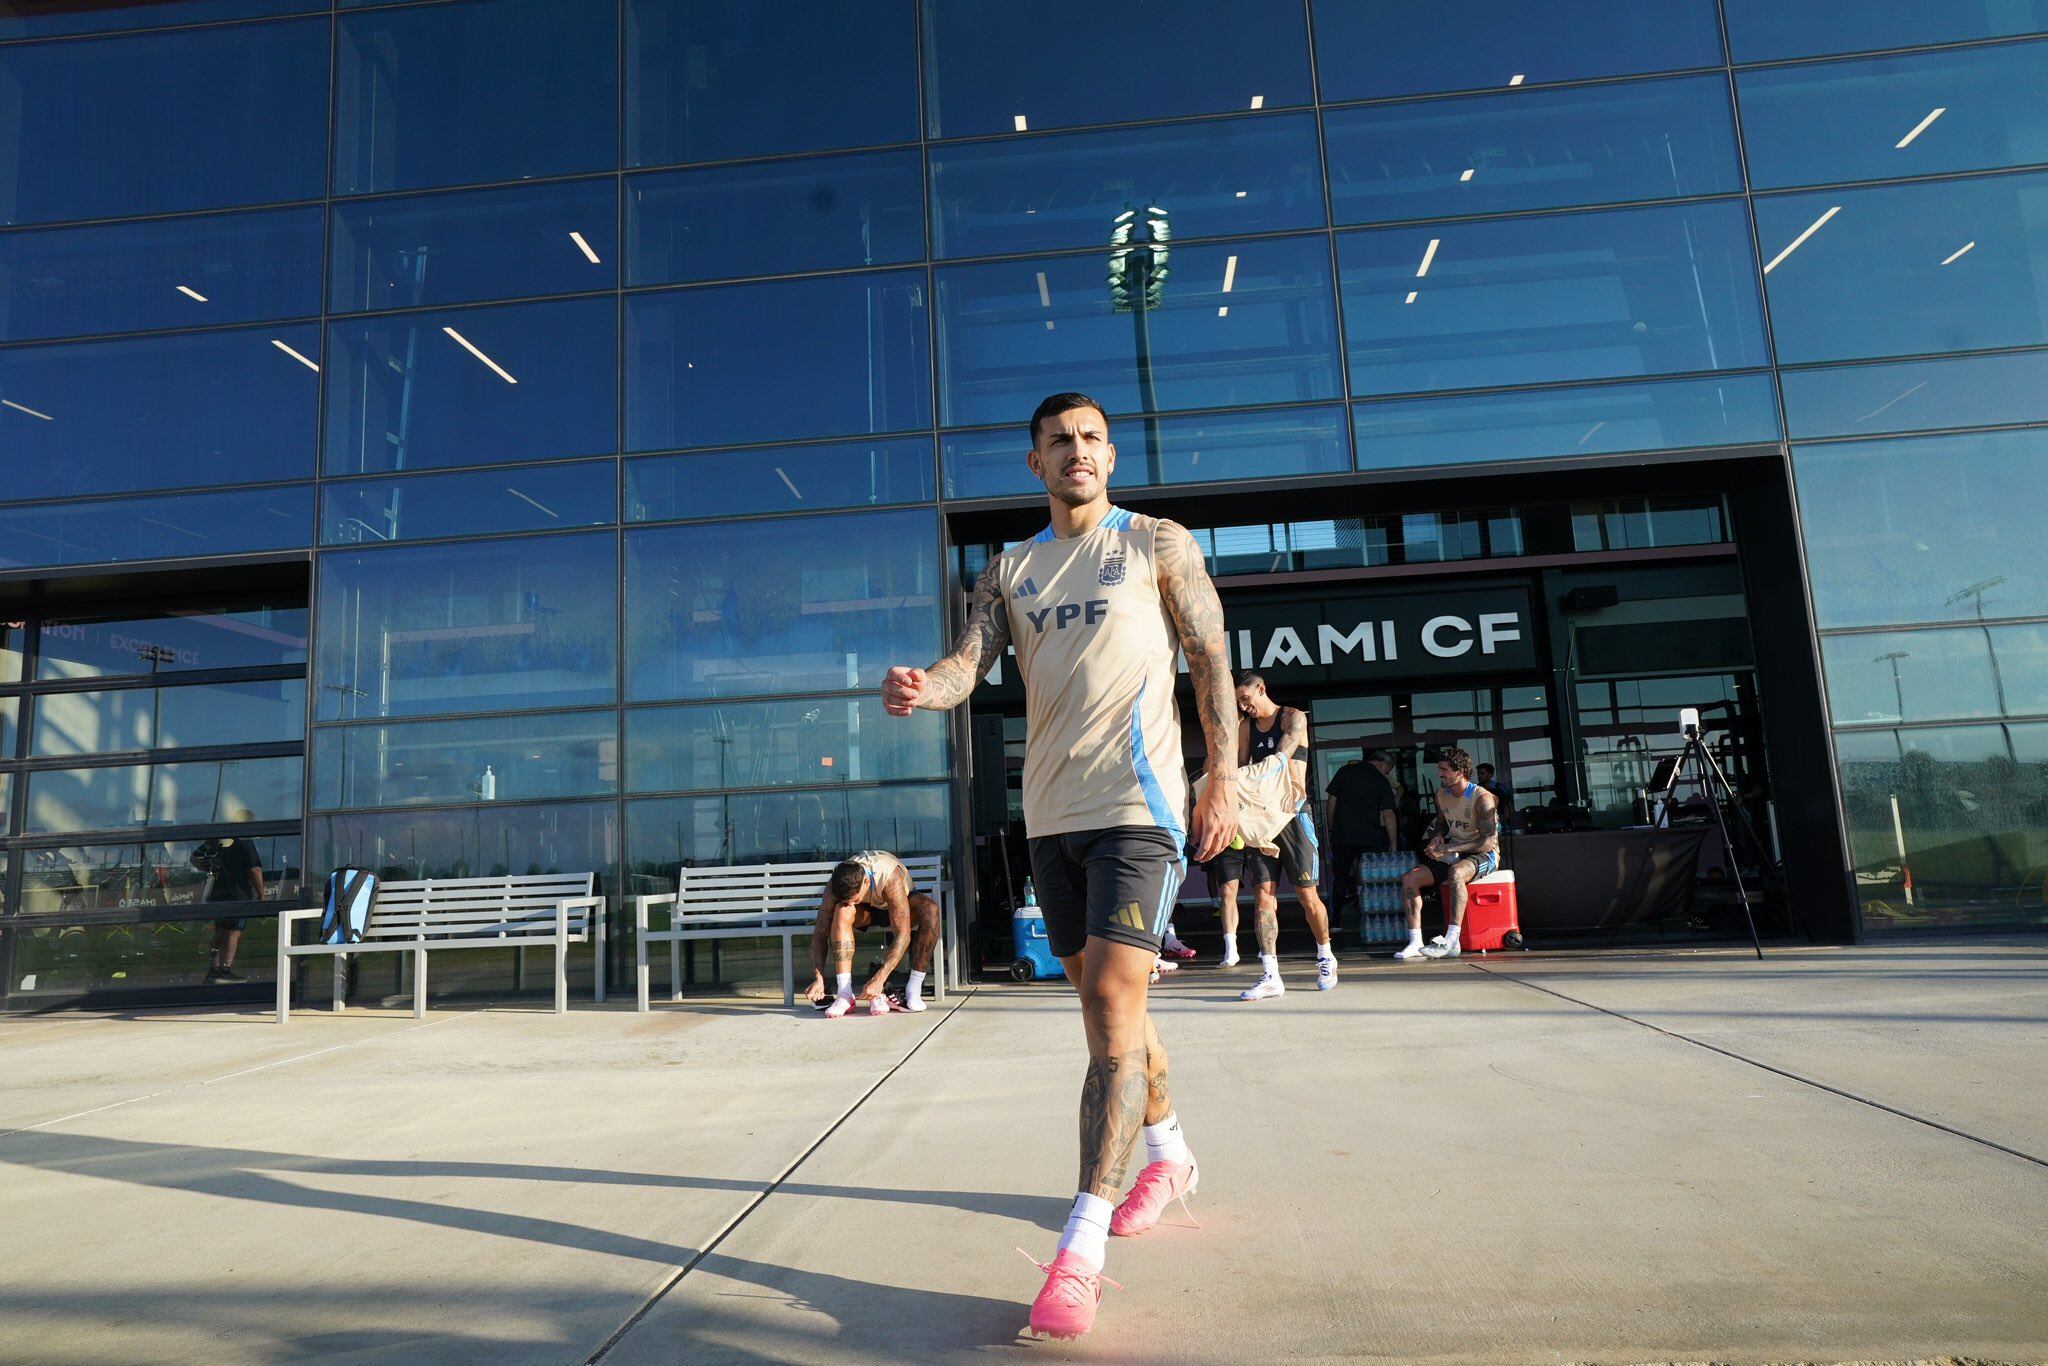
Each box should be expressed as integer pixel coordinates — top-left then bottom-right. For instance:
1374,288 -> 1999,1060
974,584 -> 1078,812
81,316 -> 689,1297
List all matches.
0,0 -> 2048,993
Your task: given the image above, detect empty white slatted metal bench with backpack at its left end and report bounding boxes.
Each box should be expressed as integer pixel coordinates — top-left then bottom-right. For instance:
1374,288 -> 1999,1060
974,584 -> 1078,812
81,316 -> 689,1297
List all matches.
276,872 -> 604,1024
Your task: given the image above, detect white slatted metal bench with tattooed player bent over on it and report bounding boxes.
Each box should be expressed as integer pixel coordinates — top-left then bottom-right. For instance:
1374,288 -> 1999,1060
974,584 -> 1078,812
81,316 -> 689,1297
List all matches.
633,854 -> 952,1010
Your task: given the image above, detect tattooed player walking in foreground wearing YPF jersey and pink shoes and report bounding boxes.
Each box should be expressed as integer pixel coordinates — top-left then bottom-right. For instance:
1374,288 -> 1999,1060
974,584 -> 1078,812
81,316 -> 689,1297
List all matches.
883,393 -> 1237,1337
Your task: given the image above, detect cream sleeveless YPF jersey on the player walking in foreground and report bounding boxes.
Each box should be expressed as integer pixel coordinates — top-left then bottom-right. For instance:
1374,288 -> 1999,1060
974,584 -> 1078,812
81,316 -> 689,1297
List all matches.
995,508 -> 1188,844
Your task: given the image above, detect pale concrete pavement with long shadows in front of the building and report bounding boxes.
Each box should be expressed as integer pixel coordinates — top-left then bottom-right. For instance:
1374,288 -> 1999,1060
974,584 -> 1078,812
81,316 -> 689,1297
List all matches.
0,940 -> 2048,1364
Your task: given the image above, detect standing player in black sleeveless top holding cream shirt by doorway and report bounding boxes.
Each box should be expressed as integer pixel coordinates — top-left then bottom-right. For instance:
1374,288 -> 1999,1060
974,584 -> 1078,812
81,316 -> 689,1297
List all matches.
1237,670 -> 1337,1001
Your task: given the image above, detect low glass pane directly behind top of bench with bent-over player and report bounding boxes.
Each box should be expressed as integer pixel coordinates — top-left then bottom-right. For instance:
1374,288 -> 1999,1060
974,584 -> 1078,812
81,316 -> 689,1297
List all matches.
627,784 -> 952,872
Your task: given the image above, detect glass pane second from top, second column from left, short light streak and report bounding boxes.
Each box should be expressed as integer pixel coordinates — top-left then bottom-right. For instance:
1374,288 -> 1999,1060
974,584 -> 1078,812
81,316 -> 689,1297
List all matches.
332,176 -> 618,313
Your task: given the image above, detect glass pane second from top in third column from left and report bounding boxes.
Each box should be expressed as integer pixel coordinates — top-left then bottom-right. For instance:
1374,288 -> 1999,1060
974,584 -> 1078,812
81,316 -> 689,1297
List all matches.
627,147 -> 924,285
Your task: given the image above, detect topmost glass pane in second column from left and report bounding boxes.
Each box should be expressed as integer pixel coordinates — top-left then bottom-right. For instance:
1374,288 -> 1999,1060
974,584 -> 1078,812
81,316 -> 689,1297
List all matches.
334,0 -> 618,195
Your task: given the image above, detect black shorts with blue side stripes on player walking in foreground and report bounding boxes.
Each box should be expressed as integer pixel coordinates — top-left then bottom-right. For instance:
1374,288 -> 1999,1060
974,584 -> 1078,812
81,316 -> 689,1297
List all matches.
1030,825 -> 1188,958
